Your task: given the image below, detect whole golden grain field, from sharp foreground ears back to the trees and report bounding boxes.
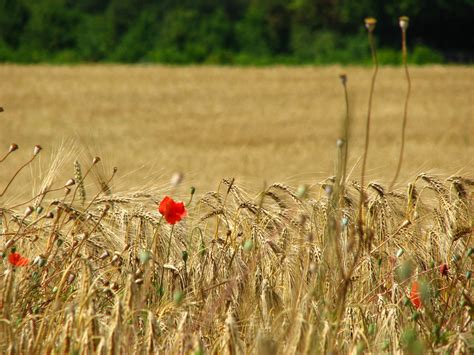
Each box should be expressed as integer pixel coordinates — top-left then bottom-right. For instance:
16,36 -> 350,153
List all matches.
0,65 -> 474,354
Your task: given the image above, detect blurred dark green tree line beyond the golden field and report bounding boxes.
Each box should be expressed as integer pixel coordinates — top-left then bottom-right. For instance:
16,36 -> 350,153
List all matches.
0,0 -> 474,65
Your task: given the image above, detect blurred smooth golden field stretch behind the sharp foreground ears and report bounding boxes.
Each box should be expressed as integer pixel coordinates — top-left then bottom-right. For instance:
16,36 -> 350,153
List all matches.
0,65 -> 474,193
